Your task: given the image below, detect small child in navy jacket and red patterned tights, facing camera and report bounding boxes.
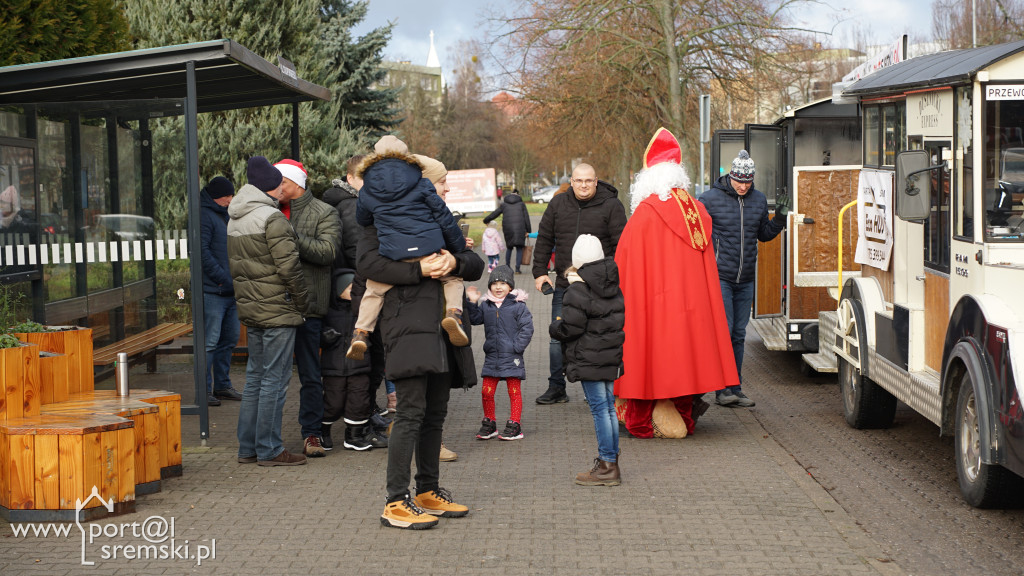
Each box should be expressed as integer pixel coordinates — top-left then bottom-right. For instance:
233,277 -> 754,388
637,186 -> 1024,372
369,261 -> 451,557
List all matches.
466,265 -> 534,440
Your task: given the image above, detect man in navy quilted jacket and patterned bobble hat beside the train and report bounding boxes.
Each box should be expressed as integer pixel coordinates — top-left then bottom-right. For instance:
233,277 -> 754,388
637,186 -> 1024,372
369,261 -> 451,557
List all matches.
699,150 -> 790,408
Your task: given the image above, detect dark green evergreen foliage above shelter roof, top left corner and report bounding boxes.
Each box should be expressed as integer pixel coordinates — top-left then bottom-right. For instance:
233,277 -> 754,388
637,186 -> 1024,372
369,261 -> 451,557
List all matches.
0,0 -> 129,66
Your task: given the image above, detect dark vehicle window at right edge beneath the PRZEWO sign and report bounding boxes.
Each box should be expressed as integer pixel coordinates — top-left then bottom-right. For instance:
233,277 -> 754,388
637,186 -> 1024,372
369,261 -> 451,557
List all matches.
982,91 -> 1024,242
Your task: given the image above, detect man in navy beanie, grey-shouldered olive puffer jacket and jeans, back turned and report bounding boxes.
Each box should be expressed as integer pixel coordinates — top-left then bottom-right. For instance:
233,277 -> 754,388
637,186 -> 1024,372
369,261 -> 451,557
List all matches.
227,156 -> 307,466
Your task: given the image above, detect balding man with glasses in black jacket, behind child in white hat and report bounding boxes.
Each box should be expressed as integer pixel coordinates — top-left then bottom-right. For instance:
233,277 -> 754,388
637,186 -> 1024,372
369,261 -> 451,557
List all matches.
534,164 -> 626,404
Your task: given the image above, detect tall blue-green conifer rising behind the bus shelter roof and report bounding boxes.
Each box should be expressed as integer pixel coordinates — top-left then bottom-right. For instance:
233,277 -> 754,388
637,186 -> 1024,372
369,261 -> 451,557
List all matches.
121,0 -> 394,204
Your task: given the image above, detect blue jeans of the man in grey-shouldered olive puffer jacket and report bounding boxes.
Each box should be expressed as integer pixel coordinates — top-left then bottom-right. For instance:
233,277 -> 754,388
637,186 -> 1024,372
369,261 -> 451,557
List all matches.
238,326 -> 295,460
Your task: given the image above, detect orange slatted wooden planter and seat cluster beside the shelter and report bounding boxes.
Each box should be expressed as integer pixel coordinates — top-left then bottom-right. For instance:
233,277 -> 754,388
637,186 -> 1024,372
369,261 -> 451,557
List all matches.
0,325 -> 184,522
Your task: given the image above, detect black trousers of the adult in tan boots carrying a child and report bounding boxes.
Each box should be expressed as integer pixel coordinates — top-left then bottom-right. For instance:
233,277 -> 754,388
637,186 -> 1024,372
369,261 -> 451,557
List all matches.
387,374 -> 452,502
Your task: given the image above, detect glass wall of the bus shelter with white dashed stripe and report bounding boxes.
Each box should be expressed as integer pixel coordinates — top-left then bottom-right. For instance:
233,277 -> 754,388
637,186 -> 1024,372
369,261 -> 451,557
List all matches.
0,99 -> 193,356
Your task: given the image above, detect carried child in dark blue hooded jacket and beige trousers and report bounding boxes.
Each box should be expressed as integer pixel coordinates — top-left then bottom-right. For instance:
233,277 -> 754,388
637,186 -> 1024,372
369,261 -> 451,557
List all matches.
346,135 -> 469,360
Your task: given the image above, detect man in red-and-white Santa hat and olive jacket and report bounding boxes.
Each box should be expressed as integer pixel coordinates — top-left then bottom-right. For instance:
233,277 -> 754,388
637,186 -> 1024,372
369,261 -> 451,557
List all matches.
274,159 -> 341,458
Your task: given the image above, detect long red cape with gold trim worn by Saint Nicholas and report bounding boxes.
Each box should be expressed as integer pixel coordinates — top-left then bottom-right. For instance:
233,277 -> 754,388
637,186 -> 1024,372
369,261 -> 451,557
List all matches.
615,190 -> 739,400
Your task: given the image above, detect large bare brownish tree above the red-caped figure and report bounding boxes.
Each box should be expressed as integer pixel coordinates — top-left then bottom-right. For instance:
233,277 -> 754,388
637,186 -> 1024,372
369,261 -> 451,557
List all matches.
495,0 -> 819,180
